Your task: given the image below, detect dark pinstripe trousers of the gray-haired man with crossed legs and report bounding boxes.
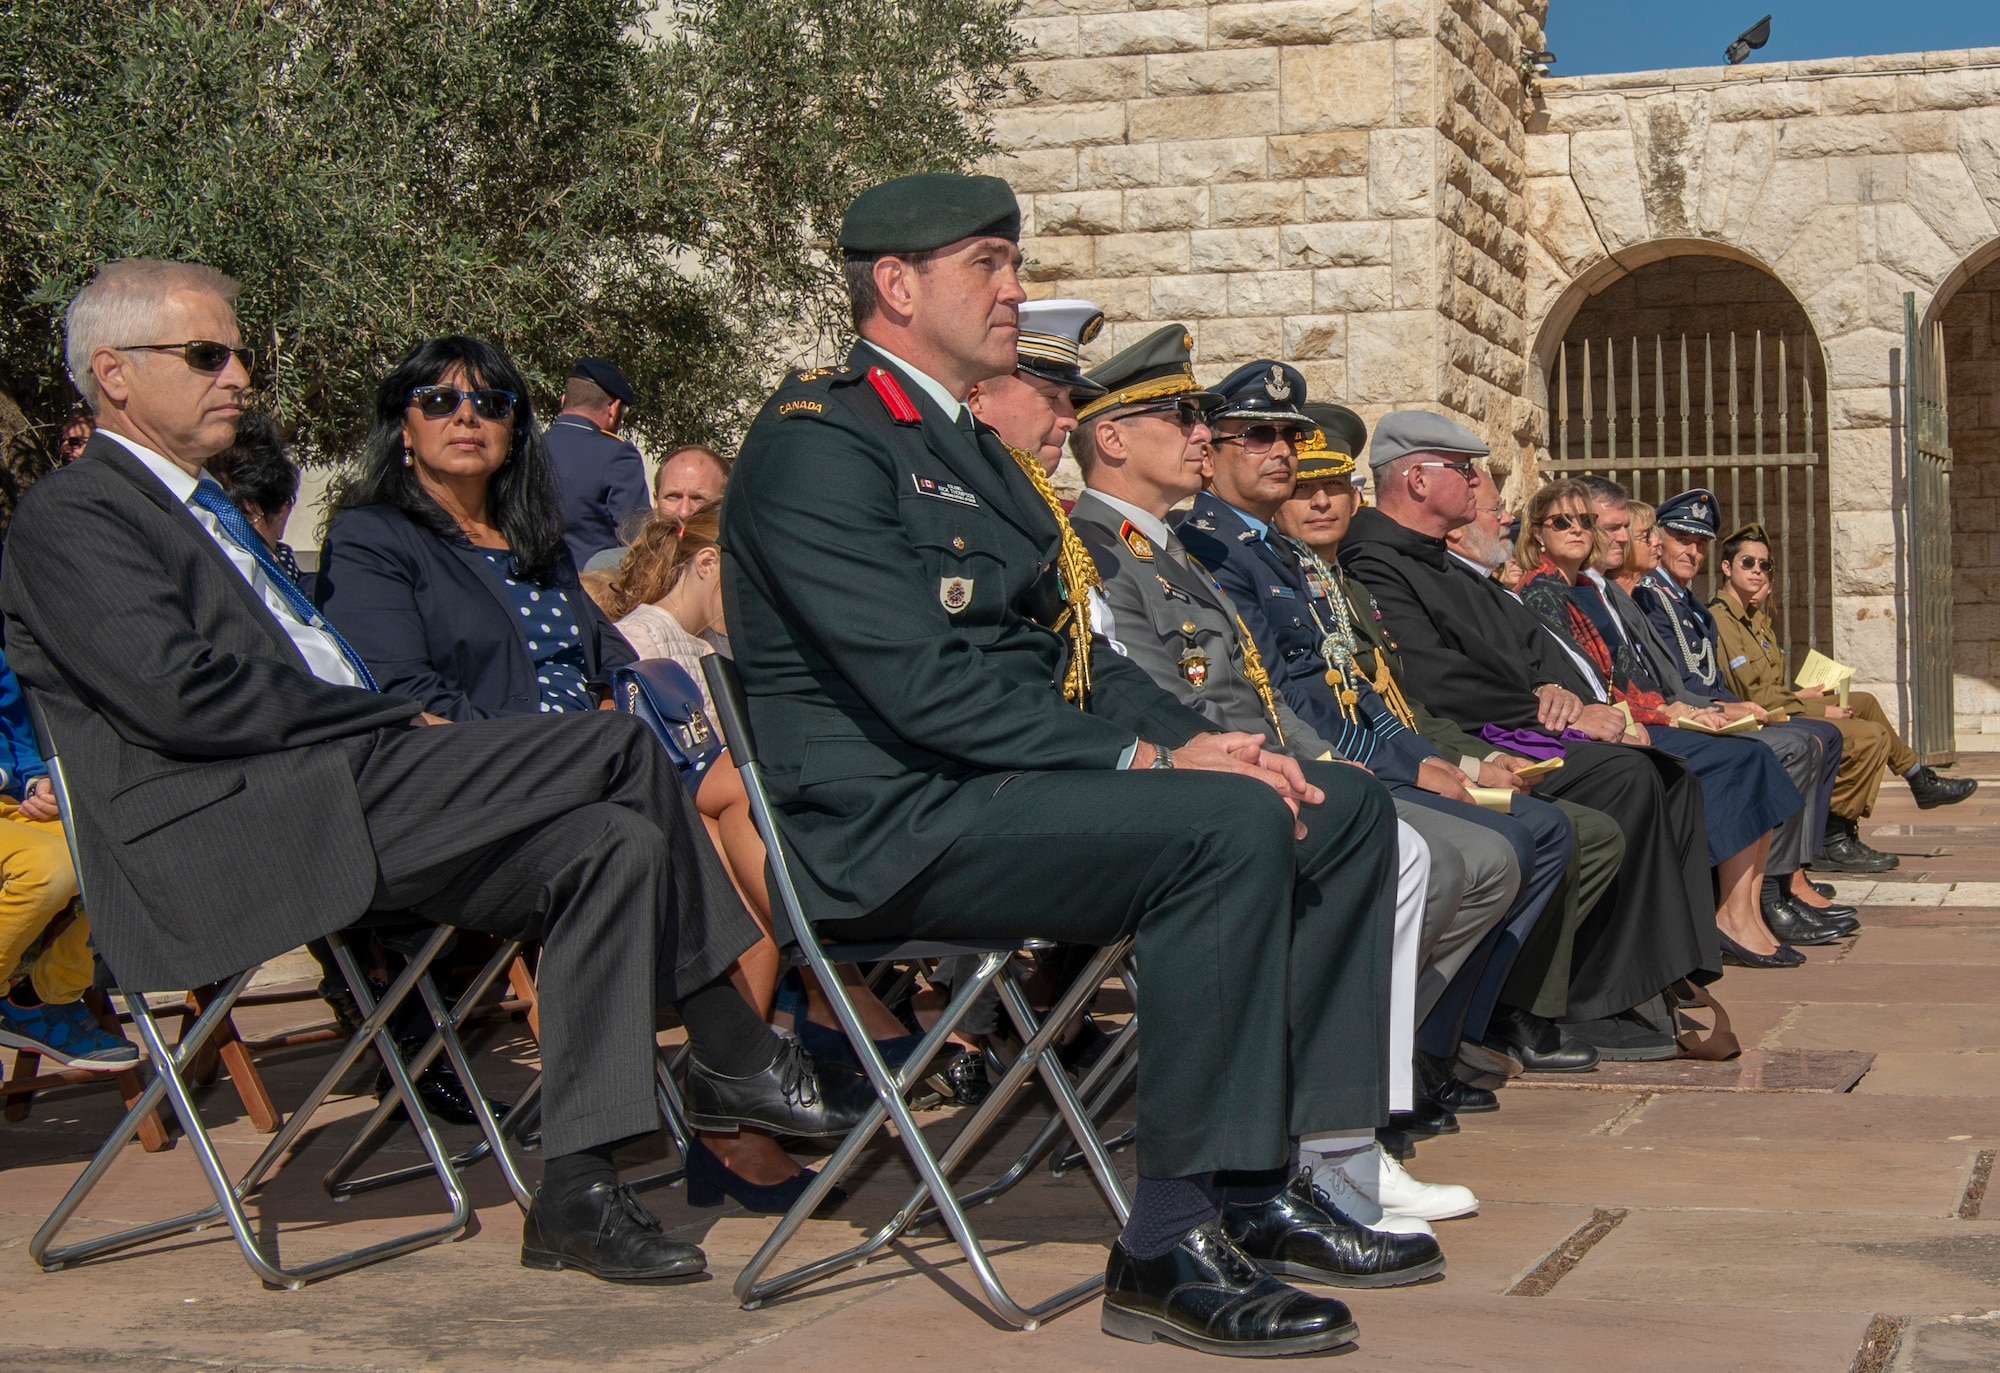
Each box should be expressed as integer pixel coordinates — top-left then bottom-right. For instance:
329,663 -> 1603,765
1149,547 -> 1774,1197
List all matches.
350,711 -> 758,1157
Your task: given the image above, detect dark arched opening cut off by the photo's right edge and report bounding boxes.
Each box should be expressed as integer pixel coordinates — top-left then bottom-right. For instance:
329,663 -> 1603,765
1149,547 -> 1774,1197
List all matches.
1932,242 -> 2000,735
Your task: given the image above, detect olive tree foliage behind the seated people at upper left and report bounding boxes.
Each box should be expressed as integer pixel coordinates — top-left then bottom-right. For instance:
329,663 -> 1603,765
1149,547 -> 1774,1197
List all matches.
0,0 -> 1018,460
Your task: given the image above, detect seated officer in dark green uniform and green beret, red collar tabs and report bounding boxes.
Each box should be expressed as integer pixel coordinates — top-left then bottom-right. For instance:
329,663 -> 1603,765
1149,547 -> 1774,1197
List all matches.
722,174 -> 1394,1355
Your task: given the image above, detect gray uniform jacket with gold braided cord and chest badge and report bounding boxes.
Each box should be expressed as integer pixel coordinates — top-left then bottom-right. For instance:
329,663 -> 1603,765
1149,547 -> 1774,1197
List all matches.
1070,490 -> 1340,759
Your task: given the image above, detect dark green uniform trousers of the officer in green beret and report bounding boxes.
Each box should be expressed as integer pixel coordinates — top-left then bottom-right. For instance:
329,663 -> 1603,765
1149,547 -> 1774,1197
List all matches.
852,763 -> 1396,1177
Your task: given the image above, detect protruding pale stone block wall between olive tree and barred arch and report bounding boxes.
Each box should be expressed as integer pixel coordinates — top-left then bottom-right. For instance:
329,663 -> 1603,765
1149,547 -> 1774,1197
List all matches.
992,0 -> 1546,486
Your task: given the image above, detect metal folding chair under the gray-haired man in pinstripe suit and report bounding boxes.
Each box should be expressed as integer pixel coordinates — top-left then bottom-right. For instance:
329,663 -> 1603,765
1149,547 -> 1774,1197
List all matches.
28,691 -> 472,1291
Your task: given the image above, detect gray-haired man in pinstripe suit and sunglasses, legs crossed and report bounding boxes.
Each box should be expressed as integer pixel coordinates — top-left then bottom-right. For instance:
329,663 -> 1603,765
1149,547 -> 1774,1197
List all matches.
0,260 -> 866,1281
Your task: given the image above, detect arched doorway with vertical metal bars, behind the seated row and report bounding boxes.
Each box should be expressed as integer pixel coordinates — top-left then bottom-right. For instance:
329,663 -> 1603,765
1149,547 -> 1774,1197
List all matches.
1536,249 -> 1834,664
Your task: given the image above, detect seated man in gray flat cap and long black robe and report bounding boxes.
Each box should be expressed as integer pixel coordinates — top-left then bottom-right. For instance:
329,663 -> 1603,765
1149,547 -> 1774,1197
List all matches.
1340,410 -> 1722,1059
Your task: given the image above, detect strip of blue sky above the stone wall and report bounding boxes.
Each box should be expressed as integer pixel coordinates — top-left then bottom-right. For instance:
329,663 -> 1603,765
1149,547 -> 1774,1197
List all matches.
1548,0 -> 2000,76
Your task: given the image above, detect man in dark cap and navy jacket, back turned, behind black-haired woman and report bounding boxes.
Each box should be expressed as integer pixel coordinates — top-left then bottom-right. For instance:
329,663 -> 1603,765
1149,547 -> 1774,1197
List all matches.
542,358 -> 652,566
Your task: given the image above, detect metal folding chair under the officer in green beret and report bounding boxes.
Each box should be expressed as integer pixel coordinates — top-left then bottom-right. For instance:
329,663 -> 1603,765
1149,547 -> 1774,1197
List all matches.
702,654 -> 1130,1331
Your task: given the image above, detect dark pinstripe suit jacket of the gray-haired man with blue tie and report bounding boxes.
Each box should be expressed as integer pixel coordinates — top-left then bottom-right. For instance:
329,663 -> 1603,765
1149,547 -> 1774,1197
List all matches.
0,434 -> 416,991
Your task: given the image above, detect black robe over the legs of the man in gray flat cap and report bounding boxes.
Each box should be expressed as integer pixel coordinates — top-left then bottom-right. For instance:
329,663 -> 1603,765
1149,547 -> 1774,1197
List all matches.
1534,743 -> 1722,1021
